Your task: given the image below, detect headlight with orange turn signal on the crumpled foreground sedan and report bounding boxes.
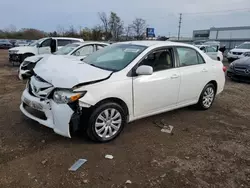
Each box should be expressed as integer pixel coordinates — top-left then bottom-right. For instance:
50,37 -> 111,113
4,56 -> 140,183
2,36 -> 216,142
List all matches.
53,89 -> 87,104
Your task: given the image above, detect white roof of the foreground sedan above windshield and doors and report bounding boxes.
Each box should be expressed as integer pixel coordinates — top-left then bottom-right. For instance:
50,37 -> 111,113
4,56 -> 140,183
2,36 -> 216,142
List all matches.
116,40 -> 195,48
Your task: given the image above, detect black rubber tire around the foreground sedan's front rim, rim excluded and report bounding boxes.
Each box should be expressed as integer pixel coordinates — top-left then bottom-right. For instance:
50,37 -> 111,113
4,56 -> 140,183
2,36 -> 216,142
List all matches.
86,102 -> 126,142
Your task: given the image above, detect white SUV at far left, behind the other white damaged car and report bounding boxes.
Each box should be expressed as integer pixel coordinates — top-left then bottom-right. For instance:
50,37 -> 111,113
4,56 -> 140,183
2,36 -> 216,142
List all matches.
9,37 -> 83,63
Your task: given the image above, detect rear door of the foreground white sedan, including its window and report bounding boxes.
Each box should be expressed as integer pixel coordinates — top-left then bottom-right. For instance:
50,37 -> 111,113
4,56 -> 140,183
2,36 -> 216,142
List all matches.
175,47 -> 212,106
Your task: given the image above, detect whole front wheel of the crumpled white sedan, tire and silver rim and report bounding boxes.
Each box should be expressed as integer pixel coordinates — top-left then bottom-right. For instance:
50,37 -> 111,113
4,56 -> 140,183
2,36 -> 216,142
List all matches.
87,102 -> 126,142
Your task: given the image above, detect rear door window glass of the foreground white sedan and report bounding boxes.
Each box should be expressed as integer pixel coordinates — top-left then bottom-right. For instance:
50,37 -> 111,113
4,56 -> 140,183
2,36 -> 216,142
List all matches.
177,47 -> 205,67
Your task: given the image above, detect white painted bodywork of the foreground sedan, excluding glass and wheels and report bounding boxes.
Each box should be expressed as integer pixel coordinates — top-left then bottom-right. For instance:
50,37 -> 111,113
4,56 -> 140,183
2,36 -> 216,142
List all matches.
20,41 -> 225,137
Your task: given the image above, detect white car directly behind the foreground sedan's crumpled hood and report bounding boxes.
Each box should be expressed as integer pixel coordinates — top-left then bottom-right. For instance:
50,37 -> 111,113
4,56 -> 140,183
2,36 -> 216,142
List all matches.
18,41 -> 109,80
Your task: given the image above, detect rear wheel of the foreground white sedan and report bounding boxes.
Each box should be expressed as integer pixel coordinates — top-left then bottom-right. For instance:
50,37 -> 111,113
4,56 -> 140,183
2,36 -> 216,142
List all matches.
197,83 -> 216,110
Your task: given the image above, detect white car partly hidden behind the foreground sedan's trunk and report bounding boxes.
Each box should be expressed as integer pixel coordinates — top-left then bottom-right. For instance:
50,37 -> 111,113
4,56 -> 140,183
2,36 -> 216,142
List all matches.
196,45 -> 223,61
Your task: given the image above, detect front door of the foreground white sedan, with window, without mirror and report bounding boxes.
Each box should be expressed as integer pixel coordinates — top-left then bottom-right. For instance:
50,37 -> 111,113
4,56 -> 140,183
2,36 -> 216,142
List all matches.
133,48 -> 180,118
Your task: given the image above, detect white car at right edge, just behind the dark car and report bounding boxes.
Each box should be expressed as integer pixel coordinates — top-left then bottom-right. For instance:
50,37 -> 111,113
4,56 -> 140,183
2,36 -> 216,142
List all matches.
227,42 -> 250,62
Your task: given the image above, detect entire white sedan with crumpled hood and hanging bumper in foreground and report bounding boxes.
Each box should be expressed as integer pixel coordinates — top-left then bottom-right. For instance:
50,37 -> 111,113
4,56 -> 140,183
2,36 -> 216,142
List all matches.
20,41 -> 225,142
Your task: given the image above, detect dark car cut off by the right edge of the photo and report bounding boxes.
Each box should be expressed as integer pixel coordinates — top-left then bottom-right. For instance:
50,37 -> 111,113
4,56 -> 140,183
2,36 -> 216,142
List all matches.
227,57 -> 250,83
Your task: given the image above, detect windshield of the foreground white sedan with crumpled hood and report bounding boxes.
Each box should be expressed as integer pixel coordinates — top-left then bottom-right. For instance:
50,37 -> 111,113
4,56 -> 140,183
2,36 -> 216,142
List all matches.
84,44 -> 147,71
